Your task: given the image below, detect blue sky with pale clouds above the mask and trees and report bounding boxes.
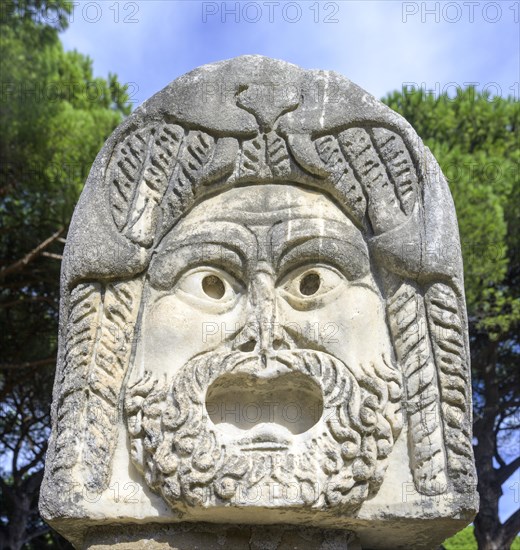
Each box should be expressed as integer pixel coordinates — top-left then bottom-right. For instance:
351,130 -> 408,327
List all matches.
58,0 -> 520,528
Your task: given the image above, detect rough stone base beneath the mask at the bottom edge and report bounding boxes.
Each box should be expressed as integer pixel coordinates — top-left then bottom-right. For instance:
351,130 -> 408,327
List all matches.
83,523 -> 361,550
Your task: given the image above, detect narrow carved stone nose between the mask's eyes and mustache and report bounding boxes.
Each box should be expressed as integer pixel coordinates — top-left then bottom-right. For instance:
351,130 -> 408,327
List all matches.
234,271 -> 294,363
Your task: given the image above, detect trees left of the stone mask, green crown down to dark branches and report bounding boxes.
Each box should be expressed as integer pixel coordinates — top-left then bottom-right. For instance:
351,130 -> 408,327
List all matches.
0,0 -> 131,550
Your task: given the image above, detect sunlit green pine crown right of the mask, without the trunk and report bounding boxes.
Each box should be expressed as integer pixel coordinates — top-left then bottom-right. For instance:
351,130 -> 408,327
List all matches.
385,87 -> 520,340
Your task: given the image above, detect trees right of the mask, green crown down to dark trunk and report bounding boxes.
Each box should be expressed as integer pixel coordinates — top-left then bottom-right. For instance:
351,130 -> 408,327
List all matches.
384,88 -> 520,550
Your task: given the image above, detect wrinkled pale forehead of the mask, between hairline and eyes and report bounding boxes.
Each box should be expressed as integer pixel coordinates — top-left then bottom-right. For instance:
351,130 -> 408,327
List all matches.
150,184 -> 369,281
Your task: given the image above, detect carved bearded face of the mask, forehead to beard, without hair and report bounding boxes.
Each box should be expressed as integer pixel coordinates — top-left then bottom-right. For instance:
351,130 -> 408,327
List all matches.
125,184 -> 401,510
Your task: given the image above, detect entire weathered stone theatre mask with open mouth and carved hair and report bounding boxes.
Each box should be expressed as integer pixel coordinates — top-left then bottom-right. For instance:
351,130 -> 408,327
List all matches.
40,56 -> 478,550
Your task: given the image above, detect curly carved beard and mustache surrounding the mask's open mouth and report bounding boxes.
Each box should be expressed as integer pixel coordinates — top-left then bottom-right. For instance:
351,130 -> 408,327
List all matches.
124,350 -> 402,512
